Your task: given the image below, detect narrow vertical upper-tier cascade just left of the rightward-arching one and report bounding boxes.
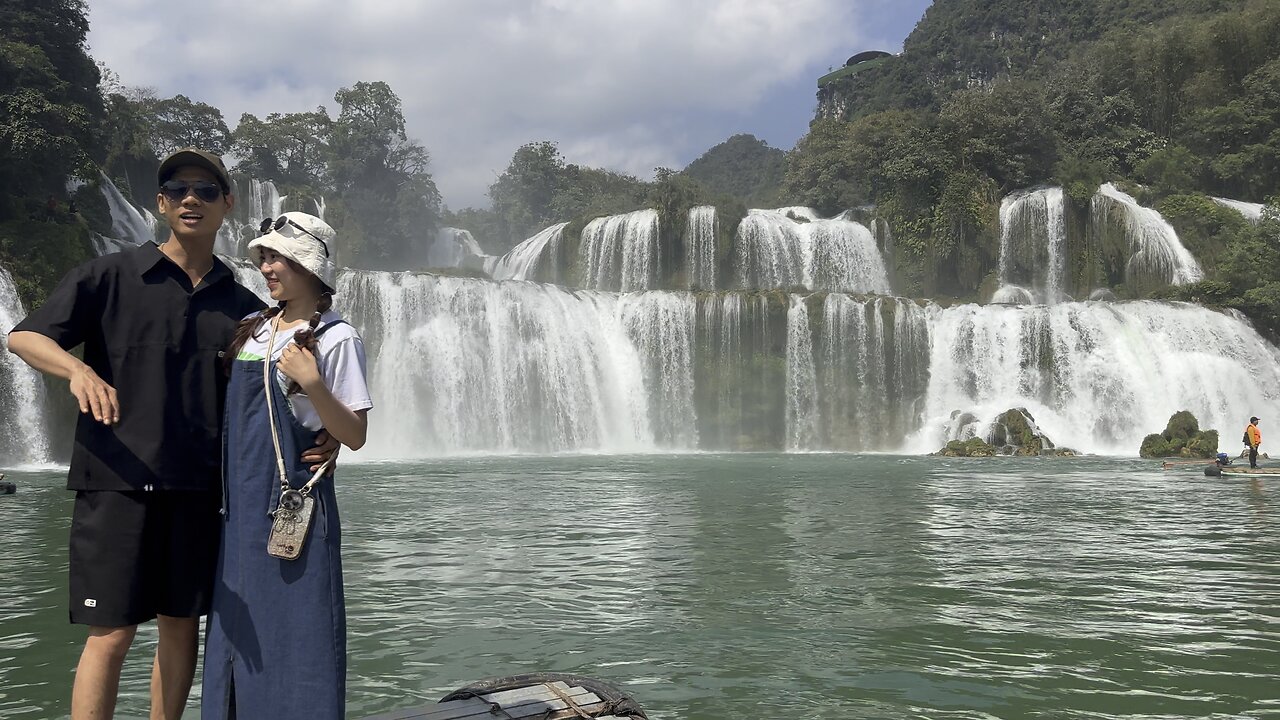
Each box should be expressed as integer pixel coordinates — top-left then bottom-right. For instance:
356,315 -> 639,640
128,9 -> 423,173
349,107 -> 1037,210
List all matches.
992,187 -> 1066,304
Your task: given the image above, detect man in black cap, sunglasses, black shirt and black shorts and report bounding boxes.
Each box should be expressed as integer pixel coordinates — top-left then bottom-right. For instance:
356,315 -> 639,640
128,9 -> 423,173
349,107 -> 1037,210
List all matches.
9,149 -> 337,720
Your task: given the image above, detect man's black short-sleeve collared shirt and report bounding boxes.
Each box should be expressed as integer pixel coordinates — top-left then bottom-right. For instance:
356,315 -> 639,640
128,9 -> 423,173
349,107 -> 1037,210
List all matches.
14,242 -> 264,491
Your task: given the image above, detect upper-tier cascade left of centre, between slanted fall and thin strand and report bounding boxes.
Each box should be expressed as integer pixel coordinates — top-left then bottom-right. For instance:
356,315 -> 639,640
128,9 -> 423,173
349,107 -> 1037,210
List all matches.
579,210 -> 659,292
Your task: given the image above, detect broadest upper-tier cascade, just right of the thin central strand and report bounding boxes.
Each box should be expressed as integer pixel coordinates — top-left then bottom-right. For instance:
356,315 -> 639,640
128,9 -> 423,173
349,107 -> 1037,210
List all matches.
733,208 -> 890,295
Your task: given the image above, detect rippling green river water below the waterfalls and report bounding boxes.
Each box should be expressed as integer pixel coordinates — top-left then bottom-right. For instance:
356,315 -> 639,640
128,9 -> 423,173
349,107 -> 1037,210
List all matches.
0,455 -> 1280,720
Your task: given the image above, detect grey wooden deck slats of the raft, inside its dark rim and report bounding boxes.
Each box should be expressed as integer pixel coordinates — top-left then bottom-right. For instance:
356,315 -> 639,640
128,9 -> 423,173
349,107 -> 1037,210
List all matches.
365,680 -> 634,720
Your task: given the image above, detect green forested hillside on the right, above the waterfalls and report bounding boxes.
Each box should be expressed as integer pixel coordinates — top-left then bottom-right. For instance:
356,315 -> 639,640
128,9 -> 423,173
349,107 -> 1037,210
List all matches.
785,0 -> 1280,329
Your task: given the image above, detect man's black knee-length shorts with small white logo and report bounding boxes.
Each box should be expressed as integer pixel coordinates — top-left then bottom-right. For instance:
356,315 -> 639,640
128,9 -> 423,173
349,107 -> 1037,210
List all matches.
70,491 -> 222,628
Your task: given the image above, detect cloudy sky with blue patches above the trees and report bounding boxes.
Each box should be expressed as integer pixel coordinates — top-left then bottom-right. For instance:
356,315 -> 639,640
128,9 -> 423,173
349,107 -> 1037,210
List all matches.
88,0 -> 929,210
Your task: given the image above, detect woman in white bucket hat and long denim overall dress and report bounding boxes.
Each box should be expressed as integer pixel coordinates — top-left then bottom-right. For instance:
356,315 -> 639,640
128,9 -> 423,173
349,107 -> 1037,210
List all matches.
200,213 -> 372,720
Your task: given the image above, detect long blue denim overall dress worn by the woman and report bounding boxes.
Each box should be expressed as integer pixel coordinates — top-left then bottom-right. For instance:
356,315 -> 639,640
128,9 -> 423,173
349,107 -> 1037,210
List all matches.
200,320 -> 347,720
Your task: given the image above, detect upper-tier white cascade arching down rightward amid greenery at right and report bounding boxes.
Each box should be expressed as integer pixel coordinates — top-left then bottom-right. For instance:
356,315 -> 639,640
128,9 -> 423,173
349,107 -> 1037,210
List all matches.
1089,183 -> 1204,284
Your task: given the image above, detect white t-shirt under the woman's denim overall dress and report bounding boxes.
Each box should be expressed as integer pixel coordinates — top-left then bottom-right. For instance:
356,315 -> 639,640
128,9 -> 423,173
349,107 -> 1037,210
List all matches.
236,310 -> 374,430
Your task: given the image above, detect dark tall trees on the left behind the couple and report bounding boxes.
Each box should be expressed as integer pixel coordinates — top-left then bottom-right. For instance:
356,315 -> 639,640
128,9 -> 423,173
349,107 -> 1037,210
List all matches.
0,0 -> 440,305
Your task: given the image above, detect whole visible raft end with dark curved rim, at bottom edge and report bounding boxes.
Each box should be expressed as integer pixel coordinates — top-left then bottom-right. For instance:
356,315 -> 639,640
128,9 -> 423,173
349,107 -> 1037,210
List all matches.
365,673 -> 648,720
